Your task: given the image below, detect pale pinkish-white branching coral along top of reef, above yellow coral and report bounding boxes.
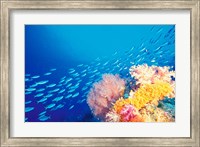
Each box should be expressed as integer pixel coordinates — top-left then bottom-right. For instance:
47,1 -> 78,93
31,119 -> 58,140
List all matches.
129,64 -> 175,98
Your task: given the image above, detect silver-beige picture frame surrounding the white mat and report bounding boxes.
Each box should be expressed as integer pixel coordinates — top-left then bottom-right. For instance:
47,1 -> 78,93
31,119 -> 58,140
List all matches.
0,0 -> 200,147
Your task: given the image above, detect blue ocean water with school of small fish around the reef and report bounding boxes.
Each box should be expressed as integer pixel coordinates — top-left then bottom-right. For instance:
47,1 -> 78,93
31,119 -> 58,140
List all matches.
25,25 -> 175,122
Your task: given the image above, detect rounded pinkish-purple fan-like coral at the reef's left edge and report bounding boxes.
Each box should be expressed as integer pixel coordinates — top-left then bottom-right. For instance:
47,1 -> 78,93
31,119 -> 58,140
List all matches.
87,74 -> 125,120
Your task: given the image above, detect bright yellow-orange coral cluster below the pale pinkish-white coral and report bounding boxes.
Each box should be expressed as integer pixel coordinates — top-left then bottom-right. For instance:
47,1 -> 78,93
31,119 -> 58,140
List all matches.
114,81 -> 173,113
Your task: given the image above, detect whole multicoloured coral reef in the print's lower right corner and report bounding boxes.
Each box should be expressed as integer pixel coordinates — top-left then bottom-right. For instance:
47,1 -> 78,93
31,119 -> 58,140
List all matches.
87,64 -> 175,122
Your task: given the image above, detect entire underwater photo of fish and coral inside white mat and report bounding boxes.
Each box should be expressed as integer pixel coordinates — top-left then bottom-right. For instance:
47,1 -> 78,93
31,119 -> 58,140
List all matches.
24,24 -> 175,122
